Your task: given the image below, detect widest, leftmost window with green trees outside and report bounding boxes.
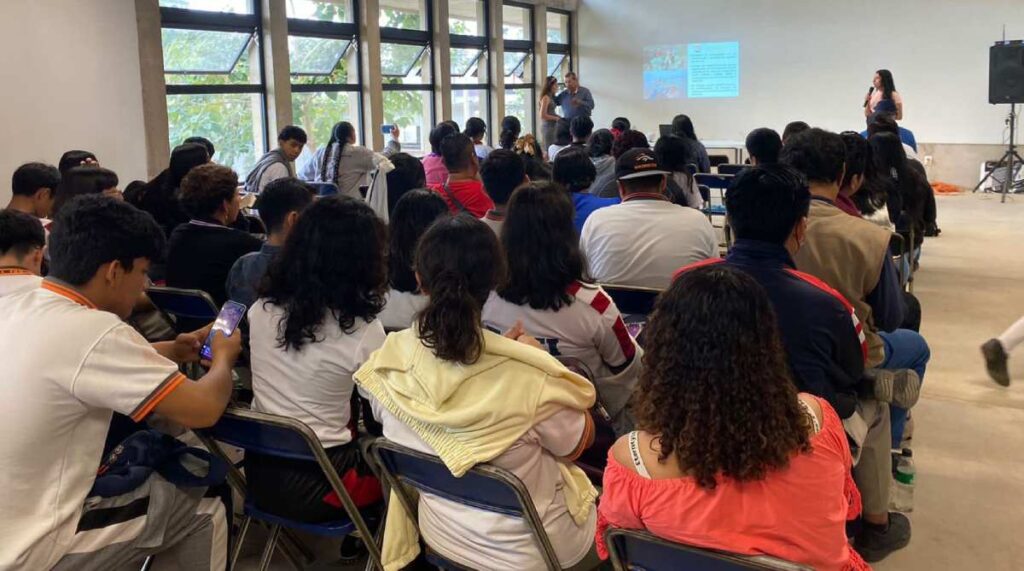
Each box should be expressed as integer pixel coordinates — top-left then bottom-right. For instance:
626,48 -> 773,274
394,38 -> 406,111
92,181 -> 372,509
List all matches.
160,0 -> 267,175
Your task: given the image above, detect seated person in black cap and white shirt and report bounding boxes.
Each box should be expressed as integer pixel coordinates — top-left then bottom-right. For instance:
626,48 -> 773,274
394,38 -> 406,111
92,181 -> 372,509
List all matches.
580,148 -> 718,290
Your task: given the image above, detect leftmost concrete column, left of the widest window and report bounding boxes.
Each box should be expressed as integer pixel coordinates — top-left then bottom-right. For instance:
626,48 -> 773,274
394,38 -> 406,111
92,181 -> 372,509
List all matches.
135,0 -> 171,177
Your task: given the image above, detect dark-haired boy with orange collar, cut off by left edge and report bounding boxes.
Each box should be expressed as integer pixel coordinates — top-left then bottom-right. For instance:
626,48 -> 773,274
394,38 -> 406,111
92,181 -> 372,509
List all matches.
0,209 -> 46,298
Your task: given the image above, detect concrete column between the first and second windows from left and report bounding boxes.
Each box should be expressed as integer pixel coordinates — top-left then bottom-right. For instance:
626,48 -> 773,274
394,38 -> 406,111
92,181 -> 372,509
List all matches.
262,0 -> 292,138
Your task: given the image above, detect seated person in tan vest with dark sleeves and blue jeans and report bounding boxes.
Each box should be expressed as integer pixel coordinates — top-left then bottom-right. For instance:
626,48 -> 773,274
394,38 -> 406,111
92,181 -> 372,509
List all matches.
781,129 -> 931,448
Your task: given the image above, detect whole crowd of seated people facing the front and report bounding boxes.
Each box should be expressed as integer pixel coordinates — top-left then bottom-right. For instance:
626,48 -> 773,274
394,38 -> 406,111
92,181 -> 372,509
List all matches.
0,105 -> 937,570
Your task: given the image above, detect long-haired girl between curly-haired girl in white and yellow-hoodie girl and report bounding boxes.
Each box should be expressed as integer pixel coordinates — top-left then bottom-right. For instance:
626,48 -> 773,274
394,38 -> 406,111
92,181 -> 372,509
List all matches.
378,190 -> 448,331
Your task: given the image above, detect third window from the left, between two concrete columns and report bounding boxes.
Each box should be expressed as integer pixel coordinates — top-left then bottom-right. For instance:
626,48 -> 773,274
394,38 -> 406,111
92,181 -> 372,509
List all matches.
380,0 -> 434,157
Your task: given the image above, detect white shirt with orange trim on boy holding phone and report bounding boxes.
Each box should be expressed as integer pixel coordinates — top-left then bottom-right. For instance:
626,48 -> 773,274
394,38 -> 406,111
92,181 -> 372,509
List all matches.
0,280 -> 186,569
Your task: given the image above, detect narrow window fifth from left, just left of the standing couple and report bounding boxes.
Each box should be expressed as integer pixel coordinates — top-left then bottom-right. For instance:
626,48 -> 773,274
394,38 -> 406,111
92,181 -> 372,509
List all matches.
502,2 -> 537,135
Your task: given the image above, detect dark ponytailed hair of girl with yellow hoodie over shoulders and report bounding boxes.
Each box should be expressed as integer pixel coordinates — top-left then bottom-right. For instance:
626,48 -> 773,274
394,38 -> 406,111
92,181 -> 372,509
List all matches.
416,214 -> 505,364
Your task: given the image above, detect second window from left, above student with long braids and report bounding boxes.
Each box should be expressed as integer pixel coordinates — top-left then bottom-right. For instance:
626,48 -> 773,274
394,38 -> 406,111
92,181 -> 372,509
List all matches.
286,0 -> 362,177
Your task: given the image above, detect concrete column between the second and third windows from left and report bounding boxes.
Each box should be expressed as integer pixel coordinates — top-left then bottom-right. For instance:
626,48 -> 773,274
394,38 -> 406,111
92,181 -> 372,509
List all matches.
359,0 -> 384,148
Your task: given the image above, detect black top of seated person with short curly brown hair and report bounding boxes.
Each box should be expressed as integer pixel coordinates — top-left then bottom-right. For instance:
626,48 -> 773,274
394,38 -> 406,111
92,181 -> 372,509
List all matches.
167,222 -> 263,306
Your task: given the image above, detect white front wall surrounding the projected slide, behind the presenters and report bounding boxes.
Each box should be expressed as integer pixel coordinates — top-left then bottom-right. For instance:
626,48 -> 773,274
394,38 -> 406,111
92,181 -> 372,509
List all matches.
580,0 -> 1024,144
